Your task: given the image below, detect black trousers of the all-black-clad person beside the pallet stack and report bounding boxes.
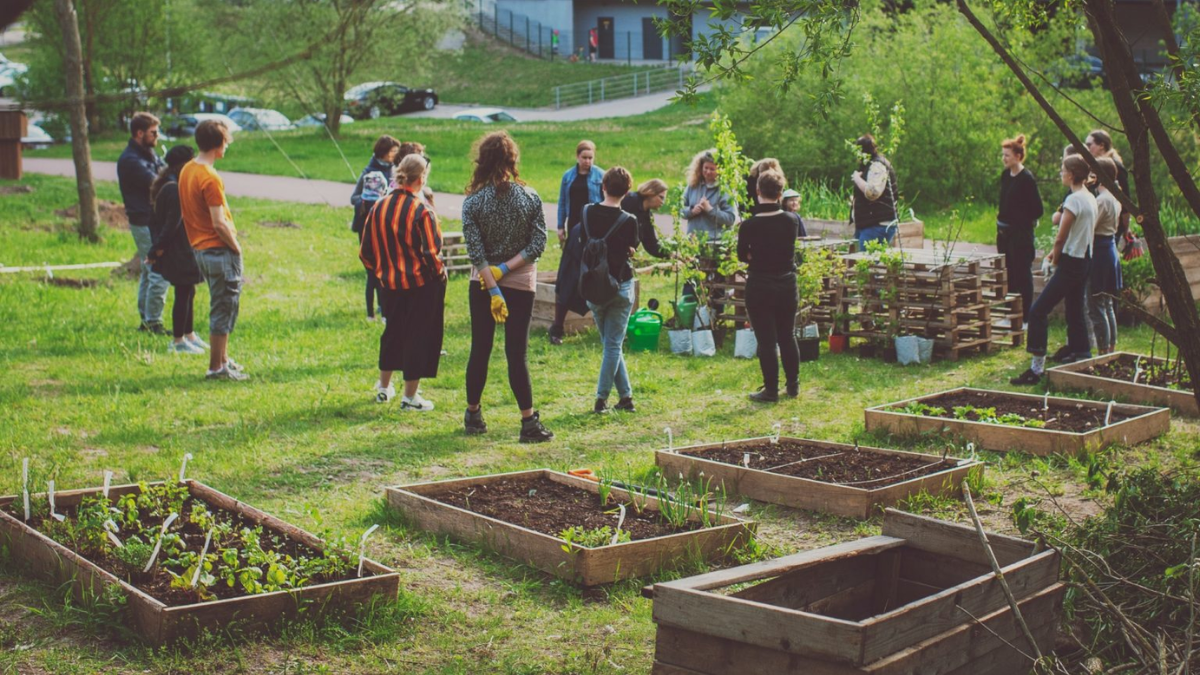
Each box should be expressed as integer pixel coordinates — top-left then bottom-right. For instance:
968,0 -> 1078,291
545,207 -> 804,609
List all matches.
746,274 -> 800,392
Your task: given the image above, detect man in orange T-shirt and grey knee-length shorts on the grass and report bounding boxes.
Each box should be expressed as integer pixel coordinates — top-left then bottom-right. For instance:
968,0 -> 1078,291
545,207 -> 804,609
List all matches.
179,120 -> 248,381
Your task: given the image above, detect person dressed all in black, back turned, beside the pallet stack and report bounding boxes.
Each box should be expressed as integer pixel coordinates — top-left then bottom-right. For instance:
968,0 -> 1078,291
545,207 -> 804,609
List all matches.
738,169 -> 802,404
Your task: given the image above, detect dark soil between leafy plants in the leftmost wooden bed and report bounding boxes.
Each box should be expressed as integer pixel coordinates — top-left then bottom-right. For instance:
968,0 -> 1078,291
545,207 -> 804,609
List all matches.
7,487 -> 364,607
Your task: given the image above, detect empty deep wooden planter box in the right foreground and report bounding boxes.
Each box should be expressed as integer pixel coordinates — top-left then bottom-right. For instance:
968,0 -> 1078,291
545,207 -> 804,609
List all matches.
650,509 -> 1064,675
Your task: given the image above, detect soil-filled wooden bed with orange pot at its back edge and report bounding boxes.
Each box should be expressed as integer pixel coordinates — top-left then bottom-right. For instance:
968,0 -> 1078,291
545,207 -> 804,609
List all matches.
386,468 -> 755,586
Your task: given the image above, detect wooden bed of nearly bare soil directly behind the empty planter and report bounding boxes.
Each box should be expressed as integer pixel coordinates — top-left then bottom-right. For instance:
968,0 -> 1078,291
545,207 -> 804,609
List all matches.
654,437 -> 983,518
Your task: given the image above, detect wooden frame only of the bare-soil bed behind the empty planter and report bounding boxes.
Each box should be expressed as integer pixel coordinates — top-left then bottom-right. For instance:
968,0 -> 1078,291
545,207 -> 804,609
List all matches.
654,437 -> 983,518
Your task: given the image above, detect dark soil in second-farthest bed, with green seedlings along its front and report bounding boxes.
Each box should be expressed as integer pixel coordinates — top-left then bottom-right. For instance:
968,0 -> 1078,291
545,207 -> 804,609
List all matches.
892,392 -> 1135,434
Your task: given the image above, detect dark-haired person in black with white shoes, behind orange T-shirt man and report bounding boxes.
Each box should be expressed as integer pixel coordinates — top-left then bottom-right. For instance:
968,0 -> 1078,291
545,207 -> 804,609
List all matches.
146,145 -> 209,354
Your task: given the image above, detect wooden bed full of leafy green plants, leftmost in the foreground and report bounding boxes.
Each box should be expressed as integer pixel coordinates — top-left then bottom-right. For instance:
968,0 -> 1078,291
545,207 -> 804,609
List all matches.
0,480 -> 400,645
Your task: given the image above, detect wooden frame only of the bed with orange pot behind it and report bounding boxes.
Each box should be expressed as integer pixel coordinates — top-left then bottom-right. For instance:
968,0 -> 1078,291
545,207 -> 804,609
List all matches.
386,468 -> 755,586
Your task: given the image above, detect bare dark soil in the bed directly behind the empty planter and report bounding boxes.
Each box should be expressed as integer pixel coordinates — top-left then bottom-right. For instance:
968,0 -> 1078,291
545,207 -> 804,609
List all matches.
684,440 -> 958,489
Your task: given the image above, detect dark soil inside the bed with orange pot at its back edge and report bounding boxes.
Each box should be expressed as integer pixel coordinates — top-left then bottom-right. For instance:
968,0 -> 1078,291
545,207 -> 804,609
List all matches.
431,476 -> 701,542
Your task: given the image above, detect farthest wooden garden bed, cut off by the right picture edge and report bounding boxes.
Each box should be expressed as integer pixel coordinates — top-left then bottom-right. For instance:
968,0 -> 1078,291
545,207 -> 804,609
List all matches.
1048,352 -> 1200,417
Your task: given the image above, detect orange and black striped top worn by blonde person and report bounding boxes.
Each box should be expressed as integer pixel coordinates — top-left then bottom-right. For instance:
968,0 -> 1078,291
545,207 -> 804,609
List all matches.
359,189 -> 444,291
